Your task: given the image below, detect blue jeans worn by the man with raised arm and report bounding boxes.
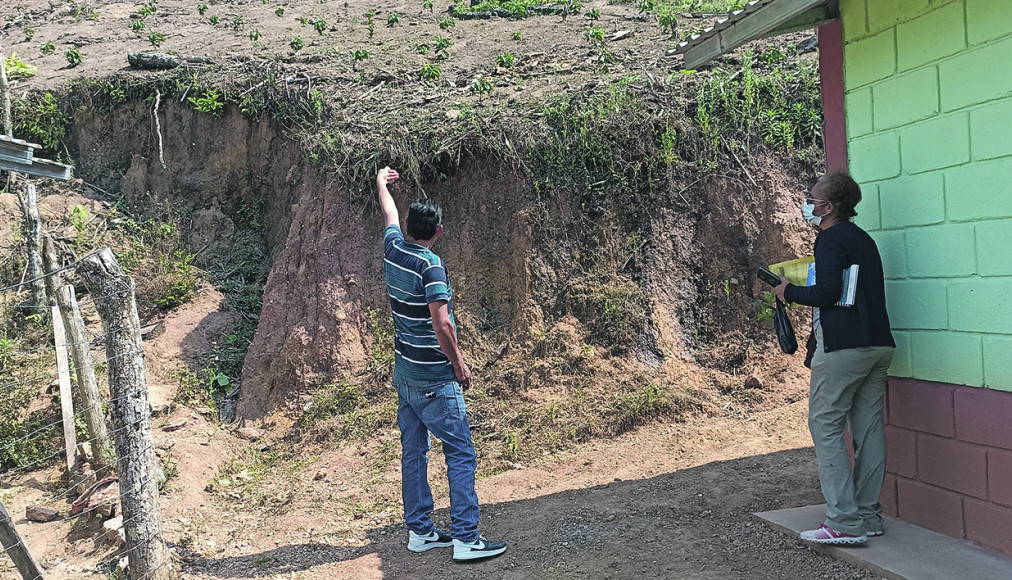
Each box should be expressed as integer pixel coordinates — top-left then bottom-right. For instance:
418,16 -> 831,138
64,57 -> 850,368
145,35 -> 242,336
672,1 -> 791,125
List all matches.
394,369 -> 479,542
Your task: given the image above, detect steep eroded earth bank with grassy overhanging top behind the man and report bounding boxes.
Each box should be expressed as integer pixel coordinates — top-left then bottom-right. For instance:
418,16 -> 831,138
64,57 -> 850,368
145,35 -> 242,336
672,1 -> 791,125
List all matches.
10,49 -> 821,472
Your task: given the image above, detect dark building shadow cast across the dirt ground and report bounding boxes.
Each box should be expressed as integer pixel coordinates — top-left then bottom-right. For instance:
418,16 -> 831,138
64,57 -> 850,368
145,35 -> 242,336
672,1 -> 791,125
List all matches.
186,448 -> 877,580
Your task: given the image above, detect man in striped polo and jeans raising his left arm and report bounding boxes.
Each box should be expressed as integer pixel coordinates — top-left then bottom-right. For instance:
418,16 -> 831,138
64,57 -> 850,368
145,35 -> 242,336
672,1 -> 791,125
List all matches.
376,167 -> 506,561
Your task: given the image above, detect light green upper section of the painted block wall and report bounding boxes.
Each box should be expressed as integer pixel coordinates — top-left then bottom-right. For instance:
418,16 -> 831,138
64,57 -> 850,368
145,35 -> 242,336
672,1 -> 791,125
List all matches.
840,0 -> 1012,391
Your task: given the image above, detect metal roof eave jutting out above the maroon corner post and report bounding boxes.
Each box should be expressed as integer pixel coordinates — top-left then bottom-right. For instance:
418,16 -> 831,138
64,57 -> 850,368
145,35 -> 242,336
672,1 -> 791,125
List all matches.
675,0 -> 836,69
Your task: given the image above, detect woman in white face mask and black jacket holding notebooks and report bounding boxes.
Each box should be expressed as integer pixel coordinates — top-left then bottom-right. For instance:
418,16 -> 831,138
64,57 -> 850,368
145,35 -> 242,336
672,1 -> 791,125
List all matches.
774,173 -> 896,544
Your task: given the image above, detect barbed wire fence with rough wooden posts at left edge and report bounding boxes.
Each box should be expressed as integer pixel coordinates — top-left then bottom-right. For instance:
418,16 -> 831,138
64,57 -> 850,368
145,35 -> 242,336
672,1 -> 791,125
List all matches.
0,241 -> 171,580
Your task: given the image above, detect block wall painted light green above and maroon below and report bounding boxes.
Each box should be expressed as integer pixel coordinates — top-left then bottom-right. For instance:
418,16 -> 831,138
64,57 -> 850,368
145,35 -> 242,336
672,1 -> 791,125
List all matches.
840,0 -> 1012,556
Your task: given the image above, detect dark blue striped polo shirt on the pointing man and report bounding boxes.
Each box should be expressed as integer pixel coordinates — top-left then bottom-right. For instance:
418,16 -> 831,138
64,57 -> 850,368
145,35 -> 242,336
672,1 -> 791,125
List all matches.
384,226 -> 456,382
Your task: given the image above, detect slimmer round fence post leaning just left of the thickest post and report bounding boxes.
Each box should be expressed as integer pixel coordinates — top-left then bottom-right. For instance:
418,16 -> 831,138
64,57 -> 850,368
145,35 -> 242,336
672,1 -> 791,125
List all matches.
57,284 -> 116,468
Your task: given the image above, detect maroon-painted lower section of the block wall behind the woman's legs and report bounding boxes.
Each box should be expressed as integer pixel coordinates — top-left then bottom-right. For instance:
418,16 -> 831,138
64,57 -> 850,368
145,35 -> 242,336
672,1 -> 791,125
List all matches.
881,379 -> 1012,556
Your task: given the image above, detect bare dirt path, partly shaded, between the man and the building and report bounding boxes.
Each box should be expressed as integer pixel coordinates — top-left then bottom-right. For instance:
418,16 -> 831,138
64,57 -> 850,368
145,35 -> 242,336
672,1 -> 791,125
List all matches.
178,401 -> 876,580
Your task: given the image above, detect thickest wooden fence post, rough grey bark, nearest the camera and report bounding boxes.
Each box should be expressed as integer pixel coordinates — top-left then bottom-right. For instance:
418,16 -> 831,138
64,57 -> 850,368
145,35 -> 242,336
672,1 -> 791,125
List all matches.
78,248 -> 169,580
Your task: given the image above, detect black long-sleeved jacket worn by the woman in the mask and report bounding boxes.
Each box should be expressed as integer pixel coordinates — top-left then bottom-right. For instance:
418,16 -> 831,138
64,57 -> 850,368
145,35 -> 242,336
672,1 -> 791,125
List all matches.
783,222 -> 896,352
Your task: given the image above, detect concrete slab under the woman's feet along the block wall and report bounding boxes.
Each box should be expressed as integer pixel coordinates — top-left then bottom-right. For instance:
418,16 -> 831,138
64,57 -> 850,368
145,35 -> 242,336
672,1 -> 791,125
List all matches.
755,504 -> 1012,580
